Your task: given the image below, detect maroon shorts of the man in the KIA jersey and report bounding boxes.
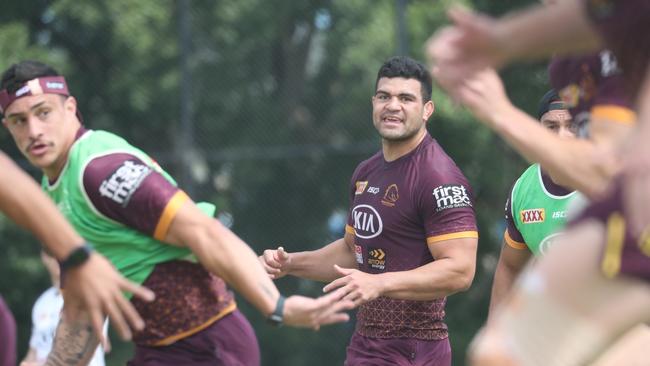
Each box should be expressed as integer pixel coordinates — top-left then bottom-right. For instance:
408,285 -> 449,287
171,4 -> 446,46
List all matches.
344,332 -> 451,366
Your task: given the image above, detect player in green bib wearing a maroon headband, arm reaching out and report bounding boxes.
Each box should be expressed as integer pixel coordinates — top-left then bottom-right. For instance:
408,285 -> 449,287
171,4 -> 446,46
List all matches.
0,61 -> 353,366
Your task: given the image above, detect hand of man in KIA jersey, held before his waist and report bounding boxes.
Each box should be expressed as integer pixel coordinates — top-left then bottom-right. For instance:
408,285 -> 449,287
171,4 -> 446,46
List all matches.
323,264 -> 382,306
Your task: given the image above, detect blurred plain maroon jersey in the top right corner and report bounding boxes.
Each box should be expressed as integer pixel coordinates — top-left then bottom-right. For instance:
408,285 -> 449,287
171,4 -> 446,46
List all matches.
585,0 -> 650,98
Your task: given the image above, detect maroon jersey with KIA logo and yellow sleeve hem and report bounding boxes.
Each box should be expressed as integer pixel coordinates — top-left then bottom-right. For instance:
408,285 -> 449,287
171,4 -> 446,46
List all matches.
346,134 -> 478,339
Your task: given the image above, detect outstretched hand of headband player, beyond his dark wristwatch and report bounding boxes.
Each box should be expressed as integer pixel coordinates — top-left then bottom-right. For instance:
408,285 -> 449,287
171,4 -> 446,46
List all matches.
284,290 -> 354,330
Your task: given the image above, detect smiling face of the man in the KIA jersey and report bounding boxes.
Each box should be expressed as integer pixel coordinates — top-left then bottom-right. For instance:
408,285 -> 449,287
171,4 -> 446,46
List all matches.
372,77 -> 433,142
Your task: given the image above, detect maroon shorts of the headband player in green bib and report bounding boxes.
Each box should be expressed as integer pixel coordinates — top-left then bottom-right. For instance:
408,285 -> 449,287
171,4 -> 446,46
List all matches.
127,310 -> 260,366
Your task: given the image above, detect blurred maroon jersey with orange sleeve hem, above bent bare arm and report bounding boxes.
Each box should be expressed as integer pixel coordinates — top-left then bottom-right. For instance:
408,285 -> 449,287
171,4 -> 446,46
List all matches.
549,50 -> 636,127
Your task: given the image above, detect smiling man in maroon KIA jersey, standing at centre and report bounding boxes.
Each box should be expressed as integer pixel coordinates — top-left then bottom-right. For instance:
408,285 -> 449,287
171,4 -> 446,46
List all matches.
261,57 -> 478,366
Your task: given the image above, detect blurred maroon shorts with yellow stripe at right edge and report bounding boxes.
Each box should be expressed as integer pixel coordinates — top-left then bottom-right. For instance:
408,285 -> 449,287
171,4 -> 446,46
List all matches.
571,180 -> 650,282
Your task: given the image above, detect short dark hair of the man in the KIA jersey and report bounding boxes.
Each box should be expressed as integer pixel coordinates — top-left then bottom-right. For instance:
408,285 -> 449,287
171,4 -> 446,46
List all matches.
375,56 -> 432,103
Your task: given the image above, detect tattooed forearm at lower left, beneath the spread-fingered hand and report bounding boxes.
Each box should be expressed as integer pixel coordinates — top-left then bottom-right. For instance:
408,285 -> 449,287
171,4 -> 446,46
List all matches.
45,318 -> 99,366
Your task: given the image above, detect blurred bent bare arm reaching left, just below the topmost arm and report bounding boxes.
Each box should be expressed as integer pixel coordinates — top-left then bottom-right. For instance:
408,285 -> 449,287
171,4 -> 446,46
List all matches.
440,69 -> 631,197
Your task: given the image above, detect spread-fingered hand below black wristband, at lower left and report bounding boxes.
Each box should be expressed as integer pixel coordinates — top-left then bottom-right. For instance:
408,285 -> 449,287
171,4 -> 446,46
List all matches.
63,253 -> 155,346
